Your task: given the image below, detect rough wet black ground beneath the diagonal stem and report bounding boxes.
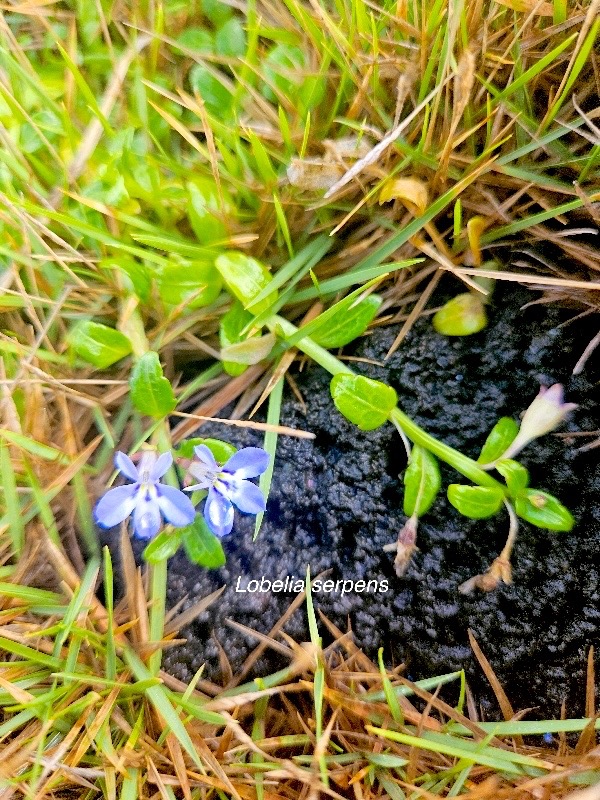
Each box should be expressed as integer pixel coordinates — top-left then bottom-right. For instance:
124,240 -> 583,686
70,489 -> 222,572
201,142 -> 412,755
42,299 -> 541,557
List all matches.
109,286 -> 600,716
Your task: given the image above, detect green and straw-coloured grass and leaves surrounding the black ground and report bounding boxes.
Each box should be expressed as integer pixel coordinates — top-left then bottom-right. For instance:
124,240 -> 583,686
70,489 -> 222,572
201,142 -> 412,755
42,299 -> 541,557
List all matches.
0,0 -> 600,800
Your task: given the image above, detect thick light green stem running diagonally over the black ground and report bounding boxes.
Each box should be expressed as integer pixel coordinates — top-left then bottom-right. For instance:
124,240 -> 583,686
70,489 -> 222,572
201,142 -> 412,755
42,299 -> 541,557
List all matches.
266,315 -> 505,491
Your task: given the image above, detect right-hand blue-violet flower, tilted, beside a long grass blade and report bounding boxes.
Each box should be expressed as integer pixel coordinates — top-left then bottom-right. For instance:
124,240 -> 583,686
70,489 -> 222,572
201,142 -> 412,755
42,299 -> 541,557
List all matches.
186,444 -> 269,536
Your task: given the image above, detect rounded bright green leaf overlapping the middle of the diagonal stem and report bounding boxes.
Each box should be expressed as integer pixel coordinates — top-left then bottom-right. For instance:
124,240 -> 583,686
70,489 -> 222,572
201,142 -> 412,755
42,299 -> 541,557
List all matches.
330,373 -> 398,431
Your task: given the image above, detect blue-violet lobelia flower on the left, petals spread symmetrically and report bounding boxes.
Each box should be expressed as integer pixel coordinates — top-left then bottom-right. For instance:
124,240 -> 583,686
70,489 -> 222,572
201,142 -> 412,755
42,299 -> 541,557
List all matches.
94,451 -> 196,539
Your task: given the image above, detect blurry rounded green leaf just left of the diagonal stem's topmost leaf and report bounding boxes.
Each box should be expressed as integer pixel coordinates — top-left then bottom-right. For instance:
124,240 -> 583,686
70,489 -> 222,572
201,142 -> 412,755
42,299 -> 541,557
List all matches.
156,257 -> 223,309
